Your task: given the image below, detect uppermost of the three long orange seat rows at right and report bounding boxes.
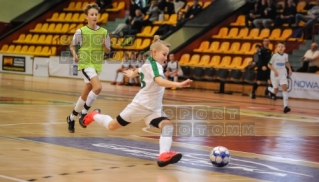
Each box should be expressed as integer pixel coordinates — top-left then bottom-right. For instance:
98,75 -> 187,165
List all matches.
212,27 -> 293,41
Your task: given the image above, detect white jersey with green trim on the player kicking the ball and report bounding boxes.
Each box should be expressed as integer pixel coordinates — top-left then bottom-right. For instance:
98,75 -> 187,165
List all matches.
132,58 -> 165,111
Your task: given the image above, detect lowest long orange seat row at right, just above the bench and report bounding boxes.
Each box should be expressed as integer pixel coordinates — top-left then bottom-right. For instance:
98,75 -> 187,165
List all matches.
179,54 -> 252,69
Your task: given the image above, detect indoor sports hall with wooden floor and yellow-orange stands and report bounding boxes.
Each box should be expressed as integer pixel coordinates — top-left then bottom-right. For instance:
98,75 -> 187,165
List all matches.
0,0 -> 319,182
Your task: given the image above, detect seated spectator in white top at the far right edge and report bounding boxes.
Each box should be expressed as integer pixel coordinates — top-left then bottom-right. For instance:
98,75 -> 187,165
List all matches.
297,43 -> 319,73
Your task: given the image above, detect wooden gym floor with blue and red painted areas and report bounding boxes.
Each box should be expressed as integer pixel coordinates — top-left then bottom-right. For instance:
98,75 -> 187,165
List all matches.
0,73 -> 319,182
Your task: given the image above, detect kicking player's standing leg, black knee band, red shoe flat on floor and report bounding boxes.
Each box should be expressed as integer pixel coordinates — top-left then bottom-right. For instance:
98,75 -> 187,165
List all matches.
145,116 -> 182,167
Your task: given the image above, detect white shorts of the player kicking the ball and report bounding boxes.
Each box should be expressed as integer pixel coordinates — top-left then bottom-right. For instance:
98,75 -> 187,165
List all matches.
120,103 -> 168,126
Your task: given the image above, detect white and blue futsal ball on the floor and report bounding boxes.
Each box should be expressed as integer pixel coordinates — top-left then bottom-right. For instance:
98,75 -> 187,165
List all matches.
209,146 -> 230,167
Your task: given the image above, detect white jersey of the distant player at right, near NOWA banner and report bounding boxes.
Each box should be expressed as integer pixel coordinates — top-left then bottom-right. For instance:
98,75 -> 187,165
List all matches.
269,53 -> 288,76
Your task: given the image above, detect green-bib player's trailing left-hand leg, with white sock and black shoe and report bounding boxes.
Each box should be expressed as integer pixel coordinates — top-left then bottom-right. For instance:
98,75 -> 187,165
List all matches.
66,78 -> 92,133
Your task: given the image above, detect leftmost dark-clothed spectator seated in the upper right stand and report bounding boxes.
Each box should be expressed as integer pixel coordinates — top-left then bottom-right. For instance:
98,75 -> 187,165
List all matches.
245,0 -> 267,28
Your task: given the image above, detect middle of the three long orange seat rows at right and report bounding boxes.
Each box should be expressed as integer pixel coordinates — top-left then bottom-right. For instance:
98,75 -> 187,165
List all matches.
193,41 -> 273,55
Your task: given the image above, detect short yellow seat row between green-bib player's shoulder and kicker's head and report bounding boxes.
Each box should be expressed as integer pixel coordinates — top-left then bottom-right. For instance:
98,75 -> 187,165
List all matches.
111,37 -> 151,50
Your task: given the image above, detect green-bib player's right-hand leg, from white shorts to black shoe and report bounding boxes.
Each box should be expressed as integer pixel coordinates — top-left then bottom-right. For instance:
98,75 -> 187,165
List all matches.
79,67 -> 102,128
